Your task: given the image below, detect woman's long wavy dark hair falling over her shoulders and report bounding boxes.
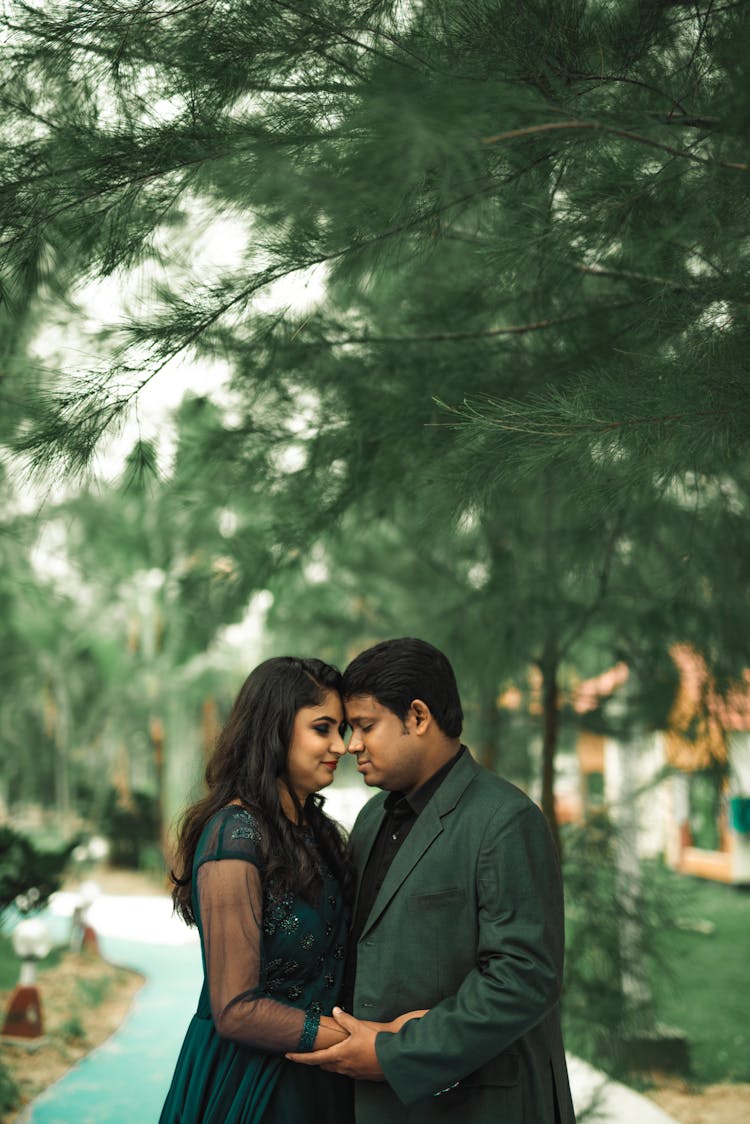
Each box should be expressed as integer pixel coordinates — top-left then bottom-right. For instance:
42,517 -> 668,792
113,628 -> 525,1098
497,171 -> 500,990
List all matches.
172,656 -> 351,925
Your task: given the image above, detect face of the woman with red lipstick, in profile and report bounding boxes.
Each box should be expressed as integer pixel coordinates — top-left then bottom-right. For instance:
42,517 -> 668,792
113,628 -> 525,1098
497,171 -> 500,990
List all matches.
287,691 -> 346,804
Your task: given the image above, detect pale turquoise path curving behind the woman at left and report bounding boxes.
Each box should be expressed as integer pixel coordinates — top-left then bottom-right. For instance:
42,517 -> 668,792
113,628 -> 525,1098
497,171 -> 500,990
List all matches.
16,937 -> 201,1124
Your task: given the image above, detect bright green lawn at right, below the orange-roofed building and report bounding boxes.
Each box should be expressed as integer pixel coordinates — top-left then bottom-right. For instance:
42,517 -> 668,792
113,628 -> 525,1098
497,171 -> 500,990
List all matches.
654,876 -> 750,1085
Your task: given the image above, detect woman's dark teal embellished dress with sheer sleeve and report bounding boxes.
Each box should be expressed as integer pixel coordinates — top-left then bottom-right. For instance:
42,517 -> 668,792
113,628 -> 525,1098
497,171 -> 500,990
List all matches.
160,806 -> 353,1124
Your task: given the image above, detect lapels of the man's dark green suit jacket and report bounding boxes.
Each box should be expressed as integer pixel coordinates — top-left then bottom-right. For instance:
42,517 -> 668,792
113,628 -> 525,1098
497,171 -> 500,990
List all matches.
358,750 -> 479,936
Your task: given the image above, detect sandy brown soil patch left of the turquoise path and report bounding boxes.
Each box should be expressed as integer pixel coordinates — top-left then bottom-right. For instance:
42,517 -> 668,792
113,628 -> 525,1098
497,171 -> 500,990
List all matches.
0,952 -> 145,1124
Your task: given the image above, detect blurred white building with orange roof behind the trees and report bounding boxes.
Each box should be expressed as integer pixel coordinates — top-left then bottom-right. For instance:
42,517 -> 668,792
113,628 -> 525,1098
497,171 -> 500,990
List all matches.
568,645 -> 750,885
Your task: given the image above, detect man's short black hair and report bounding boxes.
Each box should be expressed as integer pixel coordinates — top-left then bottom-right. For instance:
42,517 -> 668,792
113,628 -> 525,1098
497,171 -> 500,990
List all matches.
343,636 -> 463,737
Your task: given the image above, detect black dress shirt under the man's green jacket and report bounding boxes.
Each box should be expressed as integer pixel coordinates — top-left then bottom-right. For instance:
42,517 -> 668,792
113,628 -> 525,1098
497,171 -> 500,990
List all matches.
341,745 -> 468,1010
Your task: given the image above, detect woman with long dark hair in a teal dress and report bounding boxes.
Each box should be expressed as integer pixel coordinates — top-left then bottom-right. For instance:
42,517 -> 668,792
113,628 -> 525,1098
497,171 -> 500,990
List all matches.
160,656 -> 353,1124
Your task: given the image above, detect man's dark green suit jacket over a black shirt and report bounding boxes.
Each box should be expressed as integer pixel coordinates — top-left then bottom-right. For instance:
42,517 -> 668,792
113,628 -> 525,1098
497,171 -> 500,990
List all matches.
351,752 -> 575,1124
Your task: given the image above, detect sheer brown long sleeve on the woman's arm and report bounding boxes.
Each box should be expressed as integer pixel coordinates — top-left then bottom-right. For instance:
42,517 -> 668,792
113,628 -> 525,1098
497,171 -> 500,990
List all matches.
197,822 -> 320,1053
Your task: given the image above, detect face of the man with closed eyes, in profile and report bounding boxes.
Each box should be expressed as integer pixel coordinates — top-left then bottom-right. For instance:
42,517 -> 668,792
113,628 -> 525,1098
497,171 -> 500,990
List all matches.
345,695 -> 426,795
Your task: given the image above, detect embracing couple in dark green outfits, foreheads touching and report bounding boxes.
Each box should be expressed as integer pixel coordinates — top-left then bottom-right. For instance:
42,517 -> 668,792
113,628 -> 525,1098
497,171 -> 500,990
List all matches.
161,638 -> 573,1124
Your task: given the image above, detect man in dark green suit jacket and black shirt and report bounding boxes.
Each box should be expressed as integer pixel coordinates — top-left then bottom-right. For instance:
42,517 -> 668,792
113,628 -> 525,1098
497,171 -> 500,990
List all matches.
295,638 -> 575,1124
